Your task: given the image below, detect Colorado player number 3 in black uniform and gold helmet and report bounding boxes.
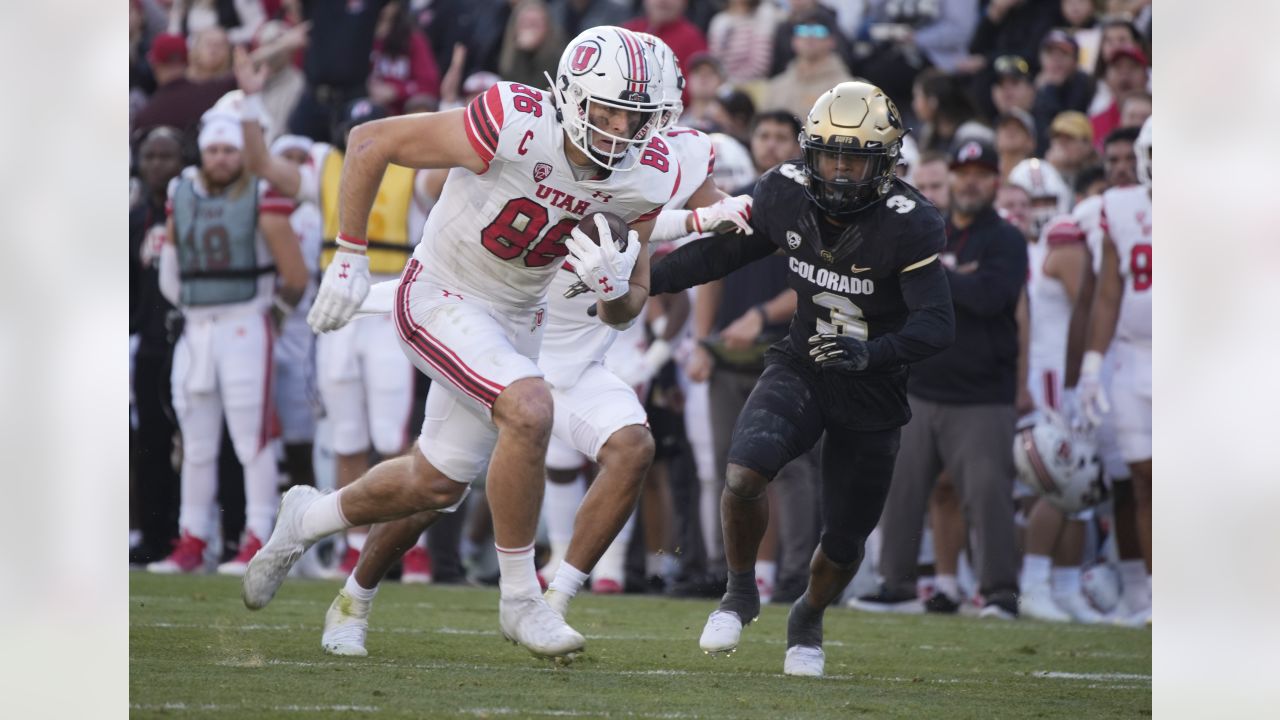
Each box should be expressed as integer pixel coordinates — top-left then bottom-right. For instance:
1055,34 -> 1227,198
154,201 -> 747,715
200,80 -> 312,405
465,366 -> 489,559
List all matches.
653,82 -> 955,675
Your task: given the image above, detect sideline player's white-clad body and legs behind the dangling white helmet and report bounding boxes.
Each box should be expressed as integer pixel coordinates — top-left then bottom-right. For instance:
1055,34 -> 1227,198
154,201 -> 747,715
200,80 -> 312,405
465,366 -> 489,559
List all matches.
1018,215 -> 1102,623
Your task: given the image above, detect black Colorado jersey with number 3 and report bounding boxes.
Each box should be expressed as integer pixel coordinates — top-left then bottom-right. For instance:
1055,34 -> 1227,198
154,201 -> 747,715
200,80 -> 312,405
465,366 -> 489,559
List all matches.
751,160 -> 946,350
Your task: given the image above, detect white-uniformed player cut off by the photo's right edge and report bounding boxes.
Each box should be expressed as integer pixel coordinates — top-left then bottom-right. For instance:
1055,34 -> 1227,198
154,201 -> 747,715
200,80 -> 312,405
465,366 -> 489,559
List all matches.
1078,118 -> 1152,624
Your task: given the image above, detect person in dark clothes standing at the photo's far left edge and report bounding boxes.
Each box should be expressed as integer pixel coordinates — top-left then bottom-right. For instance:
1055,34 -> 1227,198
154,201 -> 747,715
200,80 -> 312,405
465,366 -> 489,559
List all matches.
129,127 -> 182,565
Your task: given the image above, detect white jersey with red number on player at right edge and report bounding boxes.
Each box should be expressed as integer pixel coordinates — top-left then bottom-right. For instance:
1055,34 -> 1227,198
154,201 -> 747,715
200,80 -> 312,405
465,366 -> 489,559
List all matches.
1101,184 -> 1151,347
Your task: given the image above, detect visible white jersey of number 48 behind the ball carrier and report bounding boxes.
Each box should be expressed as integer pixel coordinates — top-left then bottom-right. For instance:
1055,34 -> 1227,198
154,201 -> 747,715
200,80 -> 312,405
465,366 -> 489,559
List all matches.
537,128 -> 716,387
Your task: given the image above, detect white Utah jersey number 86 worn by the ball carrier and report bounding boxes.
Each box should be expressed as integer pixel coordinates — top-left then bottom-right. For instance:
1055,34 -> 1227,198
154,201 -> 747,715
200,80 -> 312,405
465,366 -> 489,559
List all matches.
413,82 -> 682,307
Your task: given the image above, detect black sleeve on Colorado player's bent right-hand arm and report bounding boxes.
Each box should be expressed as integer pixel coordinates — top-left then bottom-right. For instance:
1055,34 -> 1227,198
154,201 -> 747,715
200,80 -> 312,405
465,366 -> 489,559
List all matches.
867,258 -> 956,369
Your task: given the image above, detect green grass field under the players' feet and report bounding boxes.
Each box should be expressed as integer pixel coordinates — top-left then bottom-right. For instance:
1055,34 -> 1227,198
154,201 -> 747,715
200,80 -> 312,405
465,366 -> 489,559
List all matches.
129,571 -> 1151,720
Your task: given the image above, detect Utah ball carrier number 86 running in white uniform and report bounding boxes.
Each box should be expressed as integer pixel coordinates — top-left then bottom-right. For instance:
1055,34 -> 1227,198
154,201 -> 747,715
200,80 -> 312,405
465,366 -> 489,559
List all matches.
243,27 -> 680,656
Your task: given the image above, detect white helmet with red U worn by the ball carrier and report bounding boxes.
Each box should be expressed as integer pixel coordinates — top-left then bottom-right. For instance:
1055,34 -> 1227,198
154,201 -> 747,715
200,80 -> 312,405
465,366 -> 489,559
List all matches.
547,26 -> 662,170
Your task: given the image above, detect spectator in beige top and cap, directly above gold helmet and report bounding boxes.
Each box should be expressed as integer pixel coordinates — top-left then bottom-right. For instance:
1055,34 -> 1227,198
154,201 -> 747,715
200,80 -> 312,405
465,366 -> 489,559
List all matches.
765,13 -> 854,118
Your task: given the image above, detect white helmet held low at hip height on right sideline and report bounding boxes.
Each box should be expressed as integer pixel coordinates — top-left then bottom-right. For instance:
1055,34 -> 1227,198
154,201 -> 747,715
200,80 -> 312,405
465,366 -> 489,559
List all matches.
1014,411 -> 1106,512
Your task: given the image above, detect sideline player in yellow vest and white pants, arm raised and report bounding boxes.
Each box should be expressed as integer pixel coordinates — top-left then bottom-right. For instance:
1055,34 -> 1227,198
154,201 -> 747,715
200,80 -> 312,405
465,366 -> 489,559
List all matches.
236,51 -> 431,582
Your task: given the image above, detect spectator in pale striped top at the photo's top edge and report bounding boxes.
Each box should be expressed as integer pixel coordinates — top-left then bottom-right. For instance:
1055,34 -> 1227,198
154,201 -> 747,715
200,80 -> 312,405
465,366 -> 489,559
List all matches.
707,0 -> 781,85
